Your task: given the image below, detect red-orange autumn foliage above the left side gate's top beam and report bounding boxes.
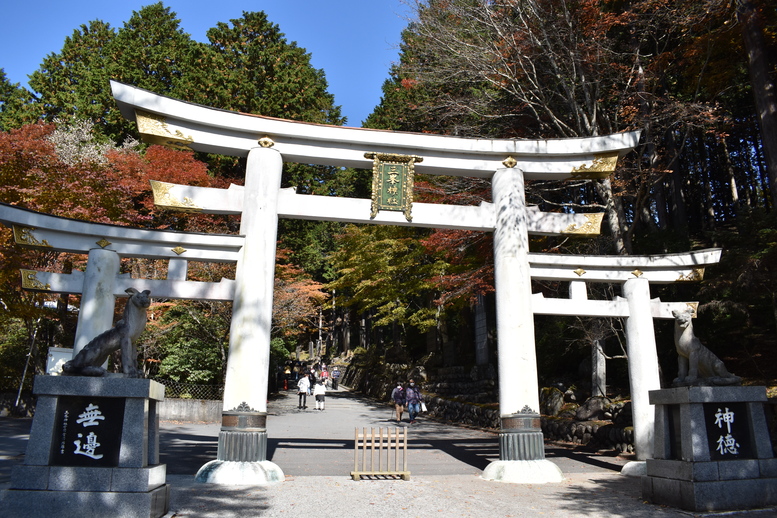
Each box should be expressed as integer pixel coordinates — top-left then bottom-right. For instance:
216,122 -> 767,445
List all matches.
0,123 -> 217,231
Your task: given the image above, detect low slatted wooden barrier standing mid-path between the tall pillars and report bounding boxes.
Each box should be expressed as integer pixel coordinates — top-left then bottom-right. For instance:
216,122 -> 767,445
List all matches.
351,428 -> 410,480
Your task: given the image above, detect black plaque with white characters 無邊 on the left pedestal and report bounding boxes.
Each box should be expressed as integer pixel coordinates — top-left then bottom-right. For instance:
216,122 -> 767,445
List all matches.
50,396 -> 124,467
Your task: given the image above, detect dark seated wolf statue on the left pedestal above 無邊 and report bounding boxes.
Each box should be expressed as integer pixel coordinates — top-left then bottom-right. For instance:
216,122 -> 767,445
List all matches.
62,288 -> 151,378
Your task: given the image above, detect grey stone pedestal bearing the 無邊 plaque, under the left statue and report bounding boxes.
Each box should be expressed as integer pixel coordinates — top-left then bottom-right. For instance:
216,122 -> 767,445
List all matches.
3,376 -> 170,518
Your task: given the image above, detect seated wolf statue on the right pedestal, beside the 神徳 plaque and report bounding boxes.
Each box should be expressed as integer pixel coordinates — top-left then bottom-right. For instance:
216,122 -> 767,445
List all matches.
672,308 -> 742,386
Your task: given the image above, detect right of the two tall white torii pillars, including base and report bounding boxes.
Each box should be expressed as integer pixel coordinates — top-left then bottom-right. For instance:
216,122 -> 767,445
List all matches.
483,167 -> 563,483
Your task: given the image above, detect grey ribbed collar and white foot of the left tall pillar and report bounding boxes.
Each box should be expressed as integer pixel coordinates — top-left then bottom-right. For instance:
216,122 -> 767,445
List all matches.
195,410 -> 285,486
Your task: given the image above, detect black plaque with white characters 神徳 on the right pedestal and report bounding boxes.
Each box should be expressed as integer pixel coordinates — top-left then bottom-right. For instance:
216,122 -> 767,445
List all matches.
704,403 -> 753,460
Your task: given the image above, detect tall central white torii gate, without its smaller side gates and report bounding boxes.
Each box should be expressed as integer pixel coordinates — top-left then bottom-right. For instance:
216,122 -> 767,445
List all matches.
111,82 -> 639,483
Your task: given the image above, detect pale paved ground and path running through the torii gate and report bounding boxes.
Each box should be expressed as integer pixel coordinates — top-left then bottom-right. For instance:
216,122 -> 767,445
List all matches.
0,388 -> 777,518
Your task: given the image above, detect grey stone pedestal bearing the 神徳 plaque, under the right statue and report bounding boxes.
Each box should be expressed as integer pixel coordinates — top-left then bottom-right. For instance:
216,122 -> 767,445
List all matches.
642,387 -> 777,512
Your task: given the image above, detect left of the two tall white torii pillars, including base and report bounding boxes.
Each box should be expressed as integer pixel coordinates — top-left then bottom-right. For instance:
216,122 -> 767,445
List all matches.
196,147 -> 284,485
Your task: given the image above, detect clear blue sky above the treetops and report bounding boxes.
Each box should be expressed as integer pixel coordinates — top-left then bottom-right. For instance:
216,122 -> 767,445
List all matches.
0,0 -> 407,126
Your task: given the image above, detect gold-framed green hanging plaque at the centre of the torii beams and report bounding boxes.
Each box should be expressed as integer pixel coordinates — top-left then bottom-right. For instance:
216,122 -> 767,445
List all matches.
364,153 -> 423,221
